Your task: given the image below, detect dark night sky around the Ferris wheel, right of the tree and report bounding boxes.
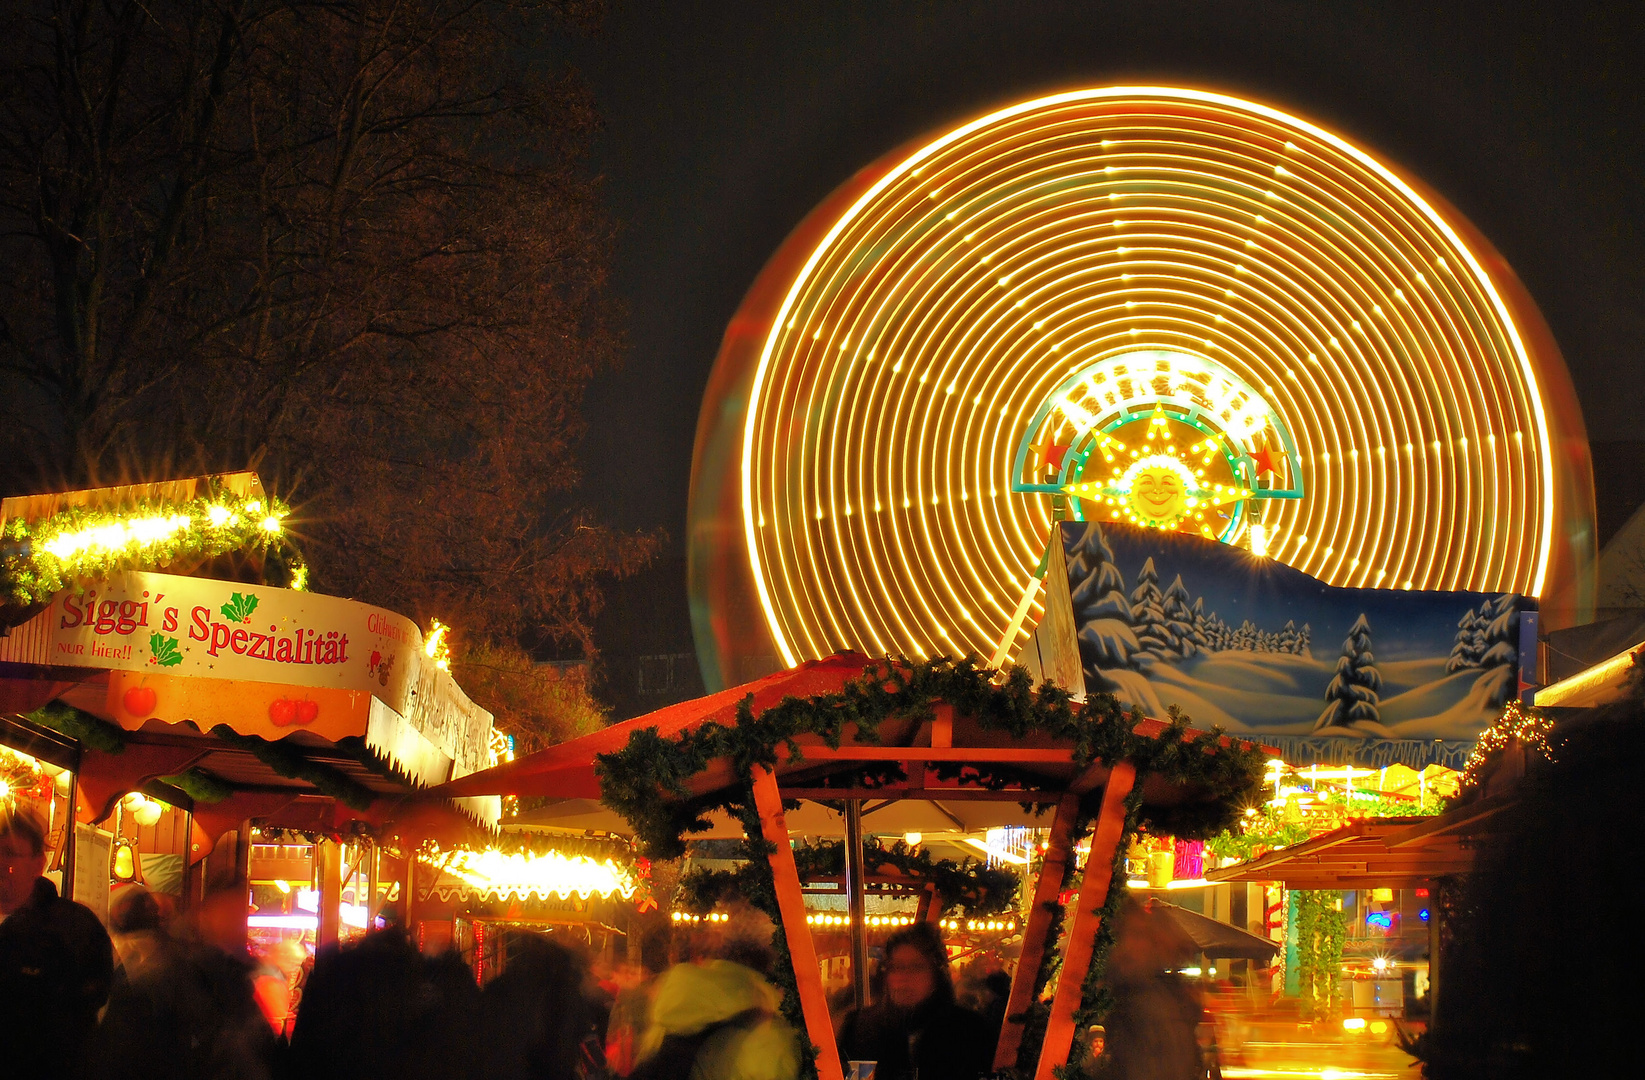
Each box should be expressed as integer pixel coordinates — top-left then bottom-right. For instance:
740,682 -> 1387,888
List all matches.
574,0 -> 1645,664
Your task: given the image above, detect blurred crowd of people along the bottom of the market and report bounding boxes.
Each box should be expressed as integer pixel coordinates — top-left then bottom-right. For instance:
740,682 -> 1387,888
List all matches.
0,814 -> 1193,1080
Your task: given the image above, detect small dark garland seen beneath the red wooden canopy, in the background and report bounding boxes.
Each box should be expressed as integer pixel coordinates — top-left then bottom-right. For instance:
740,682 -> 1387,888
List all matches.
674,840 -> 1020,917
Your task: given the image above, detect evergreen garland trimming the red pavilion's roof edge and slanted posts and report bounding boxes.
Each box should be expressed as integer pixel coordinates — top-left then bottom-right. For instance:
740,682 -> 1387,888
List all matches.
595,656 -> 1265,1077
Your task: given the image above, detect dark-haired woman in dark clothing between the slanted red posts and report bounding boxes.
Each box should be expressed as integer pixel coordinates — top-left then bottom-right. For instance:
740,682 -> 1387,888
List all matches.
839,922 -> 999,1080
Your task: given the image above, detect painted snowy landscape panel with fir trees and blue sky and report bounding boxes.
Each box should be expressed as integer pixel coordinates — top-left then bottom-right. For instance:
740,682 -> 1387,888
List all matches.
1061,521 -> 1535,750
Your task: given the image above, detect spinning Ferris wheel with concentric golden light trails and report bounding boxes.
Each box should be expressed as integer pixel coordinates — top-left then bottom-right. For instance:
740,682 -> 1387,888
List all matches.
693,87 -> 1579,677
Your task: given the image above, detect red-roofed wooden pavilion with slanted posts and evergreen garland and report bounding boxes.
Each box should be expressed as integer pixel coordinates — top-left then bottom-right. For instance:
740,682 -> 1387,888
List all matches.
441,654 -> 1262,1080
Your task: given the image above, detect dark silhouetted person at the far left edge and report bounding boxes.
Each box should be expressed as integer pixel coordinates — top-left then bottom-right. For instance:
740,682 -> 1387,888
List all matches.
0,807 -> 114,1077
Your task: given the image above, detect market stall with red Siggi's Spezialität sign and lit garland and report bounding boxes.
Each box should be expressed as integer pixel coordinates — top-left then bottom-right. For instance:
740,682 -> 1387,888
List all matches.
0,473 -> 498,940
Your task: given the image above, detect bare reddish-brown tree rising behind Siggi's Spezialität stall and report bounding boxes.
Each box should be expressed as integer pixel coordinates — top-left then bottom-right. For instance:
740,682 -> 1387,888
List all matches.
0,0 -> 653,664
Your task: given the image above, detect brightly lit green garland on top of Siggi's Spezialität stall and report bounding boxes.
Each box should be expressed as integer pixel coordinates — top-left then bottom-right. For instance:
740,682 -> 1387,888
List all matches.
0,490 -> 308,608
